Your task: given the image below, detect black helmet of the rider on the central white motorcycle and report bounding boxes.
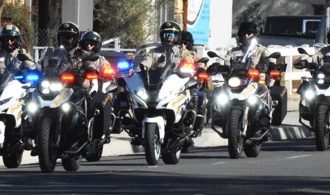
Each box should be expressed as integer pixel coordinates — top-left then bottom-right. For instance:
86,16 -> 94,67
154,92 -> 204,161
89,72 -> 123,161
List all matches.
160,21 -> 181,43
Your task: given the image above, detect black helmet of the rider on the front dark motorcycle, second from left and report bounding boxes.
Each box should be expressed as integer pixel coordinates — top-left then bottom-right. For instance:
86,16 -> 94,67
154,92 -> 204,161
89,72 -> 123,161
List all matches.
57,22 -> 80,48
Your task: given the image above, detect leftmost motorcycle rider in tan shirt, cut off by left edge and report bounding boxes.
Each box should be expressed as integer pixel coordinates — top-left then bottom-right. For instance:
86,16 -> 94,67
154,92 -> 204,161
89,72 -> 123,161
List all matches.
0,24 -> 37,76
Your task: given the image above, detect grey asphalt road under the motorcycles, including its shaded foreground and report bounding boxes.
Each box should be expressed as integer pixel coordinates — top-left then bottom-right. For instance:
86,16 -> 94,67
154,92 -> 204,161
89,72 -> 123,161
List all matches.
0,139 -> 330,194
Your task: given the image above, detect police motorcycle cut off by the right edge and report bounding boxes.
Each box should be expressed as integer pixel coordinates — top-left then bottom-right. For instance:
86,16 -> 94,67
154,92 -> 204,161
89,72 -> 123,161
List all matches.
294,48 -> 330,151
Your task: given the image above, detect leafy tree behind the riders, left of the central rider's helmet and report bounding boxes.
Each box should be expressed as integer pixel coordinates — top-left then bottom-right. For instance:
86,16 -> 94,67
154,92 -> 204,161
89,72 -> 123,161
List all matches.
93,0 -> 155,48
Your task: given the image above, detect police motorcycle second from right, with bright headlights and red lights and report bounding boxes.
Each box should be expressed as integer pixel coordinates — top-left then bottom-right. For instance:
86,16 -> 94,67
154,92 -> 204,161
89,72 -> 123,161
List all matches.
207,38 -> 280,159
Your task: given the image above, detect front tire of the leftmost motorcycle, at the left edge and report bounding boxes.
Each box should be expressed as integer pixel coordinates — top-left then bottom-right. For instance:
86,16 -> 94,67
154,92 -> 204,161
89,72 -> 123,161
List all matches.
2,141 -> 23,169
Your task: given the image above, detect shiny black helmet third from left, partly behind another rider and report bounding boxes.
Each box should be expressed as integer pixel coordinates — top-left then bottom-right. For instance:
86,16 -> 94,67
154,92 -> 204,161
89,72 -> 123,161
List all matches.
79,31 -> 102,53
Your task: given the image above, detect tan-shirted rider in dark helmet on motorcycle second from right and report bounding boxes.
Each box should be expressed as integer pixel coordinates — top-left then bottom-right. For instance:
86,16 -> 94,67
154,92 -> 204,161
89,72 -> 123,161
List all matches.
225,22 -> 274,139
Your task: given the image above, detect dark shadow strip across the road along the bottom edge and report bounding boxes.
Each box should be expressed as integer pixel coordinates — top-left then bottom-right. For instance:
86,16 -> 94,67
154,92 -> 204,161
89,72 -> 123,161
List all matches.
0,171 -> 330,195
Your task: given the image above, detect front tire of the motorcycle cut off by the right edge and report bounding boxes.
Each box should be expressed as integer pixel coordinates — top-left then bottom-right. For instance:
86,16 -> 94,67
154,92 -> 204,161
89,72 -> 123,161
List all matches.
315,105 -> 330,151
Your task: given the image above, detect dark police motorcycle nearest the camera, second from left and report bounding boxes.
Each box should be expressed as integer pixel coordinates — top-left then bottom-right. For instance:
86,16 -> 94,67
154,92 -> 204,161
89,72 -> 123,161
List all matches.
22,49 -> 113,172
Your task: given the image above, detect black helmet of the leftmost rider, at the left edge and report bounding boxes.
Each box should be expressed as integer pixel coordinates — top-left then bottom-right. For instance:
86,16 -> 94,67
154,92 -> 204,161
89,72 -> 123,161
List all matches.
0,24 -> 21,52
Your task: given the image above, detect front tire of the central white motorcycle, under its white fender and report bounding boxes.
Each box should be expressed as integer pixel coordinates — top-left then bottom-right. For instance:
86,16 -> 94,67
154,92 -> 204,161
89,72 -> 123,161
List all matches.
144,123 -> 161,165
